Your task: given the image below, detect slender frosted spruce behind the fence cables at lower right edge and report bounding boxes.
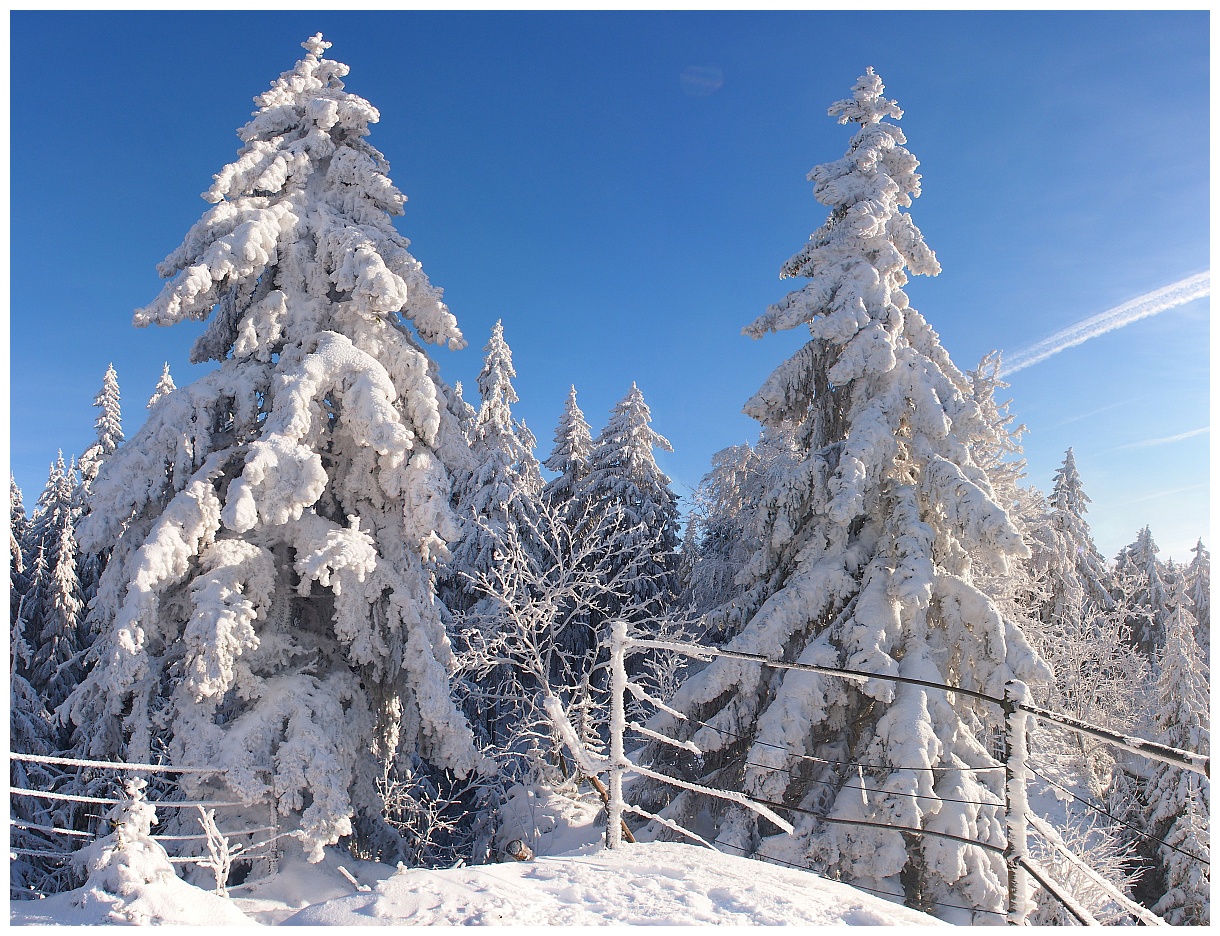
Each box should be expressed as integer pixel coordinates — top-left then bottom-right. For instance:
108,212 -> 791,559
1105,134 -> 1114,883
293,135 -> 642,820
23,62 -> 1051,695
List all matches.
1144,578 -> 1211,926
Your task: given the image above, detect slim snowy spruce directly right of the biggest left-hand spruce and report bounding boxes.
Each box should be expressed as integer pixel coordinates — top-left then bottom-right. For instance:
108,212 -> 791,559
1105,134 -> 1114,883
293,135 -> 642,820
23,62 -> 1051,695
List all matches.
445,322 -> 543,610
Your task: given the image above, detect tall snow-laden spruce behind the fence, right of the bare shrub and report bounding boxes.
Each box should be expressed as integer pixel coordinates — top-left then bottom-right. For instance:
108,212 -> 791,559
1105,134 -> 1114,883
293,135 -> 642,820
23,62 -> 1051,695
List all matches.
648,70 -> 1049,923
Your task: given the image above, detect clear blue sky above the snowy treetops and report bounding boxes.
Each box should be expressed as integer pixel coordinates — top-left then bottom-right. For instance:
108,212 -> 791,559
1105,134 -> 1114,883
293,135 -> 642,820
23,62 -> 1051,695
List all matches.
10,11 -> 1211,560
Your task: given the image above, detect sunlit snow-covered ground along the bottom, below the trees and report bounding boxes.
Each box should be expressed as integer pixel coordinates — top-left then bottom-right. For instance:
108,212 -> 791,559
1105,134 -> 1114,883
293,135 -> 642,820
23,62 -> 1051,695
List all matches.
10,797 -> 943,926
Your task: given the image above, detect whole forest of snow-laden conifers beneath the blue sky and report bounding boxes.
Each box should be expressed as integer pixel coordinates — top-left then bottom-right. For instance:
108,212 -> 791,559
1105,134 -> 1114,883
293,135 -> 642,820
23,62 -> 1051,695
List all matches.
10,23 -> 1210,926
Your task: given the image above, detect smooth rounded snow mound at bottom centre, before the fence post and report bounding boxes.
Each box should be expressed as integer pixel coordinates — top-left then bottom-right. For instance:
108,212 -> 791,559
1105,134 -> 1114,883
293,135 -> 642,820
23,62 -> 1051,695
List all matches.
284,842 -> 943,926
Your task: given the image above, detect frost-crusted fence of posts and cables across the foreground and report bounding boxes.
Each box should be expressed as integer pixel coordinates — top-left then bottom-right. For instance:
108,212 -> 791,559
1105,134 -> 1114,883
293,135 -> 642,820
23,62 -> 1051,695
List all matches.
9,622 -> 1210,925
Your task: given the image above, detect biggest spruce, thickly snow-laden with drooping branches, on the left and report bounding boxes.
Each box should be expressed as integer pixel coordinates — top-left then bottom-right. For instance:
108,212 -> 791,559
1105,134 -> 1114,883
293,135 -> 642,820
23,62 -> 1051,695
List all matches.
71,35 -> 479,860
